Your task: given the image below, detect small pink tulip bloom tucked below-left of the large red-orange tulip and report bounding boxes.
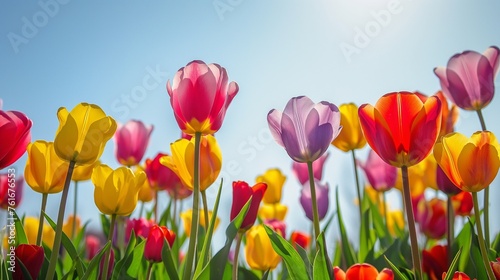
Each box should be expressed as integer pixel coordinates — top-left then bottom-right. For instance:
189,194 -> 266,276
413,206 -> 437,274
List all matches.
356,150 -> 398,192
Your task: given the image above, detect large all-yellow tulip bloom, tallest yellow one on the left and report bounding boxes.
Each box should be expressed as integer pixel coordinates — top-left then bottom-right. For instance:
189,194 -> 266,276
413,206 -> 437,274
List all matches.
54,103 -> 117,165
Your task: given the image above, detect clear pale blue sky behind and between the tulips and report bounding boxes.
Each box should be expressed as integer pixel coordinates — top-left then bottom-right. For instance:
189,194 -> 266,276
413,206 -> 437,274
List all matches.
0,0 -> 500,252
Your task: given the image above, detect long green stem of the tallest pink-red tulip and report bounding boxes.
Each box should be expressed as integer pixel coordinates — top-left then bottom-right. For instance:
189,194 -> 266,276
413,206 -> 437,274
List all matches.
183,132 -> 201,280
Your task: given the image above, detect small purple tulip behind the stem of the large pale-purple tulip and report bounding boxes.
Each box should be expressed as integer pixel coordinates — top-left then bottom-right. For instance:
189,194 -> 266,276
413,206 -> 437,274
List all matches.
300,180 -> 330,221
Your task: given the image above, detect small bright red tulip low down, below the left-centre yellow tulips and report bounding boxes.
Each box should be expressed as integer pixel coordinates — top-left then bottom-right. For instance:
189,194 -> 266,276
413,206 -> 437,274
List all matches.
144,225 -> 175,262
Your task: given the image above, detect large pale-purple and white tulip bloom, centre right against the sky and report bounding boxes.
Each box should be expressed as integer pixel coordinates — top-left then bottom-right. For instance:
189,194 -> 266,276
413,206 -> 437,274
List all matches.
267,96 -> 342,162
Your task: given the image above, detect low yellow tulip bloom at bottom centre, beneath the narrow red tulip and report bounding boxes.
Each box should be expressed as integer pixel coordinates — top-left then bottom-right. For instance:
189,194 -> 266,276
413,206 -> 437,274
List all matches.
245,225 -> 281,271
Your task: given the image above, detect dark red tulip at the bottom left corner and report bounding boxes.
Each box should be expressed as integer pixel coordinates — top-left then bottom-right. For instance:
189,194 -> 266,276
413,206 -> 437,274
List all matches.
12,244 -> 44,280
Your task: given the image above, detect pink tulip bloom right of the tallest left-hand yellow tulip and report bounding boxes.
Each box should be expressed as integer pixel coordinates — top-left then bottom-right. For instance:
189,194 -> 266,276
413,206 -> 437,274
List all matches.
115,120 -> 153,166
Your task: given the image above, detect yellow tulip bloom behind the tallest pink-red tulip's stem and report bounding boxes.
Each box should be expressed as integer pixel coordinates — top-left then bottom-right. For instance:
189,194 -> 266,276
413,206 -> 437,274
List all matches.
160,135 -> 222,191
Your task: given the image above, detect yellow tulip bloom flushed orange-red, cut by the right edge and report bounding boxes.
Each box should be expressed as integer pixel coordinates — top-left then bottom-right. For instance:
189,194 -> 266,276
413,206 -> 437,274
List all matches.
434,131 -> 500,192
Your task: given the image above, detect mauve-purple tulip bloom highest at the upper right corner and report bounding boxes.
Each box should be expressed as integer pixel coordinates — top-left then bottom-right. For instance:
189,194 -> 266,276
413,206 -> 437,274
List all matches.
434,46 -> 500,111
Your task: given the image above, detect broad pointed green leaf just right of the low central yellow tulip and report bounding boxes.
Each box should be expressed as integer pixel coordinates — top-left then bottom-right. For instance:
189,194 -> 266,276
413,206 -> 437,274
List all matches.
264,225 -> 308,280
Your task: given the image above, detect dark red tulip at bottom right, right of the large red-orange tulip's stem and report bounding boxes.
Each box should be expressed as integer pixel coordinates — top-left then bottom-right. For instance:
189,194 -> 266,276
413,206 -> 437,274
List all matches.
422,245 -> 449,280
